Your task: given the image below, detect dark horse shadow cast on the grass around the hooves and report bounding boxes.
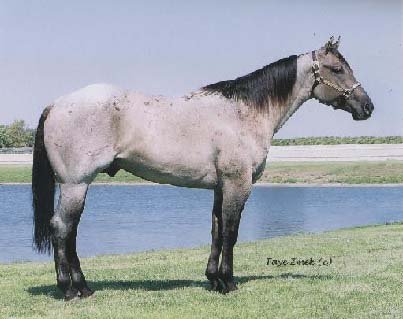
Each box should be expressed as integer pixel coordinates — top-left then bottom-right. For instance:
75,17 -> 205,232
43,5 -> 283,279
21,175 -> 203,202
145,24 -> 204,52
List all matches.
27,273 -> 333,299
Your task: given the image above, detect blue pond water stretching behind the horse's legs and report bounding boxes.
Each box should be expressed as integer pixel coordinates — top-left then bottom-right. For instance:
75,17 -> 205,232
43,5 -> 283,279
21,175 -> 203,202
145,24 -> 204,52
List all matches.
0,185 -> 403,262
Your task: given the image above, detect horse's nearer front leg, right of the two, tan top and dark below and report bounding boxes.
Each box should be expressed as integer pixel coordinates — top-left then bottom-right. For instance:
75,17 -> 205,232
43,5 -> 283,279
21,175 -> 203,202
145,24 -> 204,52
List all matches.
219,174 -> 252,293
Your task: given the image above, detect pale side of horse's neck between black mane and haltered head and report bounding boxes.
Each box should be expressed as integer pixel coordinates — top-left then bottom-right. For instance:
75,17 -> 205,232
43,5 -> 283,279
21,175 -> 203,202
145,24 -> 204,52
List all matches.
270,54 -> 314,133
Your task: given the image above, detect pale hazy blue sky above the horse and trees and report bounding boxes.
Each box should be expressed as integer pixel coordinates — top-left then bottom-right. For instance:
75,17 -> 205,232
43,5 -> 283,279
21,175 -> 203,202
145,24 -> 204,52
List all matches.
0,0 -> 403,138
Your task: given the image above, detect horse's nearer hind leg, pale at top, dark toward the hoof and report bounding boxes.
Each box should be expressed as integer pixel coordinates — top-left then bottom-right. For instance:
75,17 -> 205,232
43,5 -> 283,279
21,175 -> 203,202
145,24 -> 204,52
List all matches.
51,184 -> 88,300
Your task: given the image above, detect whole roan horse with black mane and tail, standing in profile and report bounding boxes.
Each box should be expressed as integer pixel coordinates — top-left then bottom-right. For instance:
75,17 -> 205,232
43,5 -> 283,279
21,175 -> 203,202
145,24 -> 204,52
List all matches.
32,37 -> 374,300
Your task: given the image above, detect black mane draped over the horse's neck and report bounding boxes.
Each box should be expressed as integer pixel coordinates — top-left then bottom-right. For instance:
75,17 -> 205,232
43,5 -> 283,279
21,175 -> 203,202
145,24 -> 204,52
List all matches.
202,55 -> 297,110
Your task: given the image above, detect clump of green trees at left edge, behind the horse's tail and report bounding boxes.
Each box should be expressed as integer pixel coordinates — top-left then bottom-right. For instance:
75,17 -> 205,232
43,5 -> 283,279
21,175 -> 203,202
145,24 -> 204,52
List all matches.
0,120 -> 35,148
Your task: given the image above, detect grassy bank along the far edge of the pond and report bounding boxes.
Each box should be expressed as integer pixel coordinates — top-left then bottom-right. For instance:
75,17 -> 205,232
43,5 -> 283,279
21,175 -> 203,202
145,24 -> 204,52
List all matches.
0,161 -> 403,184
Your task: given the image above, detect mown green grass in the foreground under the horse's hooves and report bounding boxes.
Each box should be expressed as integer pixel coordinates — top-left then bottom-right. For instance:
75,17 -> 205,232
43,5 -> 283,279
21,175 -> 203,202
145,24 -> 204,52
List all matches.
0,224 -> 403,319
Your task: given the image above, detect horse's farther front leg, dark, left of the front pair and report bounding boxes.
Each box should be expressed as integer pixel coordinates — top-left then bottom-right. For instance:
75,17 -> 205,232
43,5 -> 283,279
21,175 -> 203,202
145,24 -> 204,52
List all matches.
206,189 -> 222,291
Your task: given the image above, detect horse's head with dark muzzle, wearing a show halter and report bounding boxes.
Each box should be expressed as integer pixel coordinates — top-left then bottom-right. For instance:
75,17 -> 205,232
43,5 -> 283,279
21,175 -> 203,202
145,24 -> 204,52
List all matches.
312,37 -> 374,120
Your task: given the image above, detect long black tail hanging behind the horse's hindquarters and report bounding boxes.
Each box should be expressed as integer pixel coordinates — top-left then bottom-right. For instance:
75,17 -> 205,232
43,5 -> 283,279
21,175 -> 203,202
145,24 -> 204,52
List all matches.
32,106 -> 55,254
